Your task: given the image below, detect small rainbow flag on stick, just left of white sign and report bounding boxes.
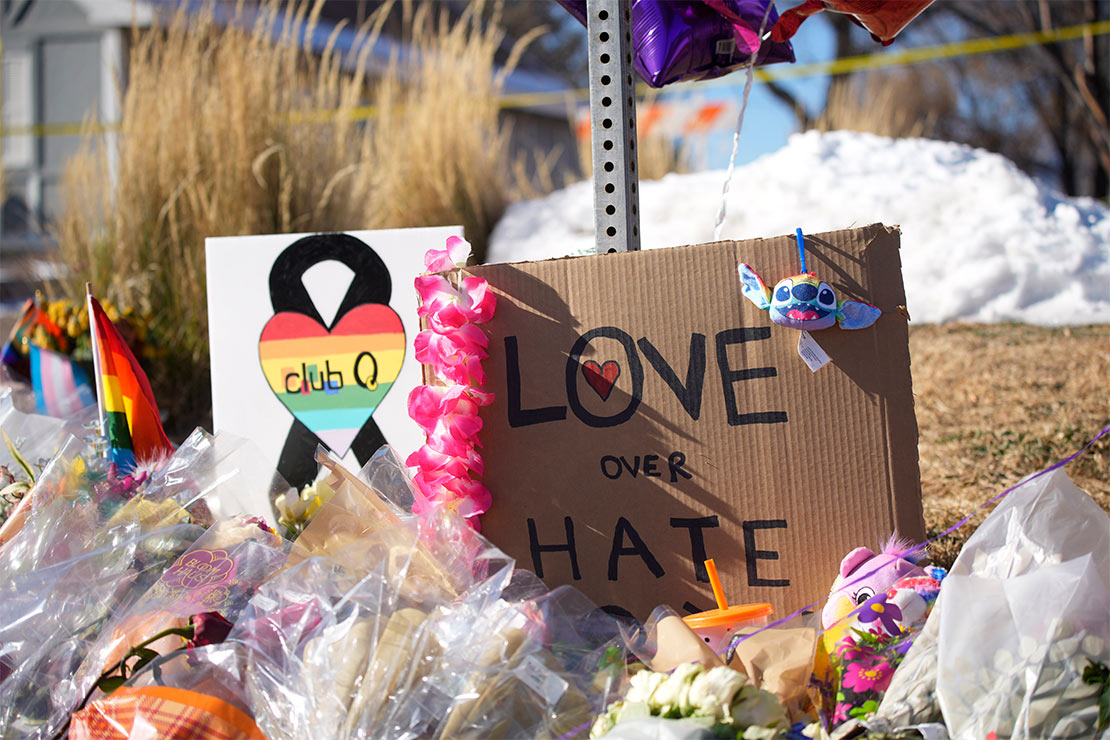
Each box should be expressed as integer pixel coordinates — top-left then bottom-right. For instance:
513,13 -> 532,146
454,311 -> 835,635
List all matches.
89,295 -> 173,472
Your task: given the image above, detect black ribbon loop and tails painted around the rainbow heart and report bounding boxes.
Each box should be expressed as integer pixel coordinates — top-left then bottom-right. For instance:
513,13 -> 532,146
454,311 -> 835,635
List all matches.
270,234 -> 393,490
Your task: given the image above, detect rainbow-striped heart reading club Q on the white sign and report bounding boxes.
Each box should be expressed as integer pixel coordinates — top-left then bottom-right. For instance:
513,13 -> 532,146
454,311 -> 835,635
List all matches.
259,303 -> 405,457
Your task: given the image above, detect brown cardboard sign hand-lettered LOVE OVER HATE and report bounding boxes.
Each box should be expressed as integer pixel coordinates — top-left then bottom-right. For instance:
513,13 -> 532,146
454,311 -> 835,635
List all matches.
466,225 -> 925,619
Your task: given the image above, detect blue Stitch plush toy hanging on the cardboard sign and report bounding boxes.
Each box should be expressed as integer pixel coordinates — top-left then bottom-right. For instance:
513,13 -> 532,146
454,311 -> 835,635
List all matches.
737,229 -> 882,332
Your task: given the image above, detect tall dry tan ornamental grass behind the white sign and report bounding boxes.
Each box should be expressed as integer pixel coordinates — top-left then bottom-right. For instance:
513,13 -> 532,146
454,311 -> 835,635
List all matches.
57,0 -> 531,434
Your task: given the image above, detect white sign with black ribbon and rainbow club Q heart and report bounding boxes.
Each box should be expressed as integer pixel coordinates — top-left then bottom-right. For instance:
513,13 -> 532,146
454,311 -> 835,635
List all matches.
205,226 -> 462,487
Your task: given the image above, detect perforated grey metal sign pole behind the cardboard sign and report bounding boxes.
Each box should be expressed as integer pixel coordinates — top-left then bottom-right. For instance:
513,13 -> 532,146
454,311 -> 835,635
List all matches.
586,0 -> 639,254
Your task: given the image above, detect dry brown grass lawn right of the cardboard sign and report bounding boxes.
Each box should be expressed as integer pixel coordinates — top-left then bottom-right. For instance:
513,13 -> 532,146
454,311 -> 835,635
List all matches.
910,324 -> 1110,565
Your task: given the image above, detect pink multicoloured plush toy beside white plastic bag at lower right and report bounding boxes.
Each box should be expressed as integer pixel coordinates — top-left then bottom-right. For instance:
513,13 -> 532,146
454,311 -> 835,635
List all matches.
821,535 -> 945,653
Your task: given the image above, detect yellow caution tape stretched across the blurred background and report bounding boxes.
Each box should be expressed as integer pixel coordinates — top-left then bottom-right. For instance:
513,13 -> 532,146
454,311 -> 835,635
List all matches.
0,21 -> 1110,136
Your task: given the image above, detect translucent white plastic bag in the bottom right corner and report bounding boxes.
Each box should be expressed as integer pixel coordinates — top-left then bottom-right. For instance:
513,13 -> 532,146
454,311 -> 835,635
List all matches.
937,470 -> 1110,740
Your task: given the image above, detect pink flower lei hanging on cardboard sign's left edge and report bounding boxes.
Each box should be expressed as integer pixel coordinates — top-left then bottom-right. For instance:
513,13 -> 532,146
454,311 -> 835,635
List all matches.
405,236 -> 497,529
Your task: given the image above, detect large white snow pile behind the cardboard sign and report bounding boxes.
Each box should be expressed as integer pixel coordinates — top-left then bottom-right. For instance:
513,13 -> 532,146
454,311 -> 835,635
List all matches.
488,131 -> 1110,325
